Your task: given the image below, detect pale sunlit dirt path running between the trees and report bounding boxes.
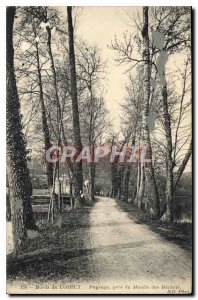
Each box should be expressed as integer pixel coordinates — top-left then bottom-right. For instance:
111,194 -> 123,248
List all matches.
86,198 -> 191,289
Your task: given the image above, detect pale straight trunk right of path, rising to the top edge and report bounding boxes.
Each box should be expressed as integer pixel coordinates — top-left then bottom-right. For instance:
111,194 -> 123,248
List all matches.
140,7 -> 159,217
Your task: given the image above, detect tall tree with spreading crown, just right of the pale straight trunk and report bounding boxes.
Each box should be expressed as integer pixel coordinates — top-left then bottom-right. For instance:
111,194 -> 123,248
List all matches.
151,7 -> 190,222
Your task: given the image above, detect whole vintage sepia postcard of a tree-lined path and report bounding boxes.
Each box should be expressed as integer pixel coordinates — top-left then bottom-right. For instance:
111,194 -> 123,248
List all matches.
6,2 -> 193,295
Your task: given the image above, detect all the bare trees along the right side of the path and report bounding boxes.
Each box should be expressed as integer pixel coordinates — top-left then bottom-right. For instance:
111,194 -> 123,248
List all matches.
110,7 -> 192,221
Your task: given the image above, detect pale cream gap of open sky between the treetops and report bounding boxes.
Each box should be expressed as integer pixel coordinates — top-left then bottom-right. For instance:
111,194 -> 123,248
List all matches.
73,7 -> 132,131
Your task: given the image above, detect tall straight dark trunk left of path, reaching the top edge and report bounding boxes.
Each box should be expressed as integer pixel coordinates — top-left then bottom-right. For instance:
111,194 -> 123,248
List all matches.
67,6 -> 83,206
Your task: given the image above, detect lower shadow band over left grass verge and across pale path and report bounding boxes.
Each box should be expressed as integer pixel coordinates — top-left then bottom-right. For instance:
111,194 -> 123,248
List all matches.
7,239 -> 159,282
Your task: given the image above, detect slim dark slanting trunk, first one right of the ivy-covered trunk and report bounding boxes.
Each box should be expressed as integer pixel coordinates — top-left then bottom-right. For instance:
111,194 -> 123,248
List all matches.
36,43 -> 53,187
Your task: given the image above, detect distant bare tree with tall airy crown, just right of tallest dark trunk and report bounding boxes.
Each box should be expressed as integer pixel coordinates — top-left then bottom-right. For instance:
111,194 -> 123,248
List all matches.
76,41 -> 109,201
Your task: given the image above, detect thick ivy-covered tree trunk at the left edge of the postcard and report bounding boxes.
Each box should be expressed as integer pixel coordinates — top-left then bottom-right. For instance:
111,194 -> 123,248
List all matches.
6,7 -> 36,252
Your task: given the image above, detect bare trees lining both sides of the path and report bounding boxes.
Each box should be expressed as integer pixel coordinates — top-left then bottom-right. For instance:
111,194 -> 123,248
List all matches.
7,6 -> 192,253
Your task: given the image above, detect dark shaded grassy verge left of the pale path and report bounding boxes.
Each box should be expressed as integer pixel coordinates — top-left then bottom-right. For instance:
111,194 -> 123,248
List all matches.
7,202 -> 97,283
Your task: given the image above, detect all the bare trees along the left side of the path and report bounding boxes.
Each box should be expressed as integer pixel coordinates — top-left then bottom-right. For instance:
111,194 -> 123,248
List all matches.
7,6 -> 108,251
